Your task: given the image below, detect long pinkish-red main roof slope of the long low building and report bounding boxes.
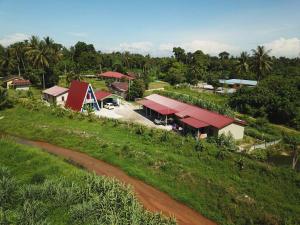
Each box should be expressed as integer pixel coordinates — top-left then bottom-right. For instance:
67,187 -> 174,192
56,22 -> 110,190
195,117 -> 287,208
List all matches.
146,94 -> 235,129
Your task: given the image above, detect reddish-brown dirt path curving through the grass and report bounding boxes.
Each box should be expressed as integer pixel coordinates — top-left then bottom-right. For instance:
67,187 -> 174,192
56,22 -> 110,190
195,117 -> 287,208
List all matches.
17,138 -> 216,225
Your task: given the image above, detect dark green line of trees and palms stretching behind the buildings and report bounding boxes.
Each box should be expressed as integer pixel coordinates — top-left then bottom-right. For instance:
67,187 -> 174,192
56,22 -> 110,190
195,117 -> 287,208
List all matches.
0,36 -> 300,129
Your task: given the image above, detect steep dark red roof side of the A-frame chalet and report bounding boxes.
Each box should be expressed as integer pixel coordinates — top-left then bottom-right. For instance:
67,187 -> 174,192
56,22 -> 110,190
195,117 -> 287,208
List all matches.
66,80 -> 89,111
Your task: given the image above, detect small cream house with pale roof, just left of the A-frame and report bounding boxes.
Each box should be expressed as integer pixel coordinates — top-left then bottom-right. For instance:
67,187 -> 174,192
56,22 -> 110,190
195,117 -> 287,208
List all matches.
43,86 -> 69,106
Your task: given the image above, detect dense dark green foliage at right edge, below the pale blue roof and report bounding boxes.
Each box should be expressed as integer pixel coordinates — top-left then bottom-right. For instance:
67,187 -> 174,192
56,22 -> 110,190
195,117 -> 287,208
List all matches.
230,76 -> 300,129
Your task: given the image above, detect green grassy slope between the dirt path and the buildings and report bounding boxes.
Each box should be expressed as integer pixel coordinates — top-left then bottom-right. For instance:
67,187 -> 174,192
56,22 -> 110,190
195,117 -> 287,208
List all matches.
0,102 -> 300,224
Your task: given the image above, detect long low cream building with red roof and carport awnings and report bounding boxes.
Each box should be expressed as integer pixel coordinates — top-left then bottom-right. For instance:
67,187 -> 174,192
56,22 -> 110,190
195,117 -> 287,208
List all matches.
138,94 -> 245,140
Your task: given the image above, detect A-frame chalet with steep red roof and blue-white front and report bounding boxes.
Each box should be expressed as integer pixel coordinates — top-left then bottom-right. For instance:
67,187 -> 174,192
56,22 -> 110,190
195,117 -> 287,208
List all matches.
66,80 -> 100,112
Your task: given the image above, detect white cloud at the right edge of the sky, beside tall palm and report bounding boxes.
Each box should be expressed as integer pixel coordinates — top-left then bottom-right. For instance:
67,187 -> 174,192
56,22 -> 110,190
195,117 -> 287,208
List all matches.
264,38 -> 300,57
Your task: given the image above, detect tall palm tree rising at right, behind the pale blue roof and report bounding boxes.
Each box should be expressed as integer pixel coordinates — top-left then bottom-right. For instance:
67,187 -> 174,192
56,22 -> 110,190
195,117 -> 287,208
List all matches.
251,46 -> 272,80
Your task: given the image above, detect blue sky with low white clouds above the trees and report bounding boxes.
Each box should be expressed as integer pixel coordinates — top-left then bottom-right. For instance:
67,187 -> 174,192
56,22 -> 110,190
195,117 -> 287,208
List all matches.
0,0 -> 300,57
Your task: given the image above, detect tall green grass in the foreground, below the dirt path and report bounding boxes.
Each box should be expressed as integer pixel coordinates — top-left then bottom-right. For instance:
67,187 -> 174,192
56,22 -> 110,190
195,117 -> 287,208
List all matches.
0,137 -> 175,225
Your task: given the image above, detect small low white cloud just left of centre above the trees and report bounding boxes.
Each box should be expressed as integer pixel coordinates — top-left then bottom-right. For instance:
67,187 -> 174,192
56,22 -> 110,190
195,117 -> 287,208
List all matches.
113,41 -> 153,54
